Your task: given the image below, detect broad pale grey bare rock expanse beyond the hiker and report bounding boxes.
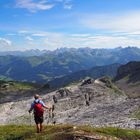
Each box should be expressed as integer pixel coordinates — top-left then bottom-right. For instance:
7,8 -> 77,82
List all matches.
0,79 -> 140,129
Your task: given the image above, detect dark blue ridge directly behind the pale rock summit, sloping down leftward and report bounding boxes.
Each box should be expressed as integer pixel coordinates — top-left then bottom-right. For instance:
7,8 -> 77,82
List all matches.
44,64 -> 120,88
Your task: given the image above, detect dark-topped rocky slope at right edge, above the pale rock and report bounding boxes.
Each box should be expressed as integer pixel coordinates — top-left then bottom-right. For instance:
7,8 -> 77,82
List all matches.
115,61 -> 140,98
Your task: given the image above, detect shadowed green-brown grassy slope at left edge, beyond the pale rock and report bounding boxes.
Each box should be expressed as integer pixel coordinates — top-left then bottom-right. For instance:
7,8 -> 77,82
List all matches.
0,80 -> 40,103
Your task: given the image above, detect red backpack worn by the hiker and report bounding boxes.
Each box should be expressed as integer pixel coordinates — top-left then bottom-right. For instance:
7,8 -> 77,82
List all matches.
34,101 -> 44,117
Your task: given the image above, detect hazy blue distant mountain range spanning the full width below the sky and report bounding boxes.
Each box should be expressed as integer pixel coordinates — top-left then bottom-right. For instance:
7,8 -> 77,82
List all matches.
0,47 -> 140,83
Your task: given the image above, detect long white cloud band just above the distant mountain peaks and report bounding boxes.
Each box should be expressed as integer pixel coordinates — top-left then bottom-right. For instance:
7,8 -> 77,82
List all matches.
25,32 -> 140,50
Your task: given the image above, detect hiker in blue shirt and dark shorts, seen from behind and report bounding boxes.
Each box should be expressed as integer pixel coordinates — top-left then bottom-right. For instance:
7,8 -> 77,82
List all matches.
29,94 -> 51,133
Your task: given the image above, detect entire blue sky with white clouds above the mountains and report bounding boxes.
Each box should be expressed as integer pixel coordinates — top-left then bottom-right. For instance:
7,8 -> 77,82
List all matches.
0,0 -> 140,51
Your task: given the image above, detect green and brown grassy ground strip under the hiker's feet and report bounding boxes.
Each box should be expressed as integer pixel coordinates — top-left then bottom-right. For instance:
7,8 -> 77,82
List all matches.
0,125 -> 140,140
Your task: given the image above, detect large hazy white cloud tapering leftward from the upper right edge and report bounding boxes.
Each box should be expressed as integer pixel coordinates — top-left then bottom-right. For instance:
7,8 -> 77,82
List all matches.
80,11 -> 140,32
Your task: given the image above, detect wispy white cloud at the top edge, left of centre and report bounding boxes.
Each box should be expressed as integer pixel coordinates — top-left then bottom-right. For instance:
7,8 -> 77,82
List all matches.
16,0 -> 54,13
